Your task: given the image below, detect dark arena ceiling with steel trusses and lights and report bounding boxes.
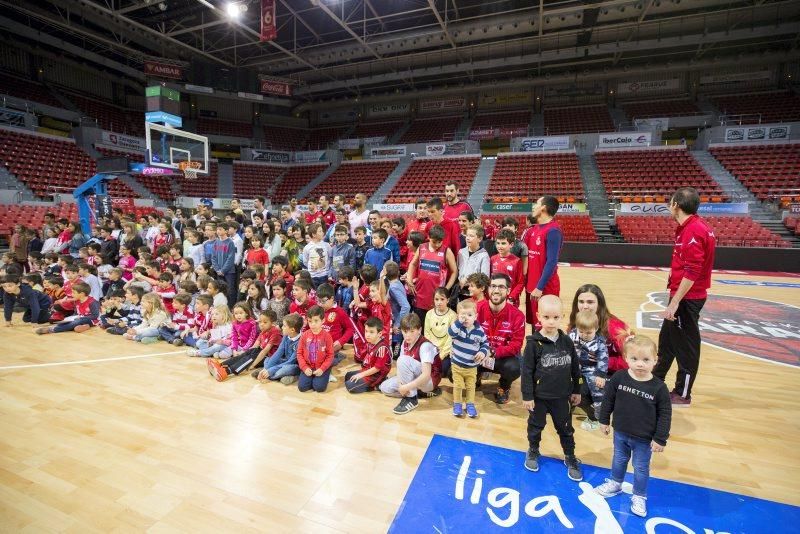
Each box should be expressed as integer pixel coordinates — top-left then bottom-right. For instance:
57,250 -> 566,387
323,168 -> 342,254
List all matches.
0,0 -> 800,99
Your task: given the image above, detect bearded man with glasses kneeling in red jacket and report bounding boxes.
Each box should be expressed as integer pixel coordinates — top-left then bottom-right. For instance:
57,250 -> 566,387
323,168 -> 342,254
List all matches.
476,273 -> 525,404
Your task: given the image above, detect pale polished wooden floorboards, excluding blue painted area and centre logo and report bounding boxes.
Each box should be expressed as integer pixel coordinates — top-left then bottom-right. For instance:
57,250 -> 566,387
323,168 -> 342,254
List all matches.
0,267 -> 800,533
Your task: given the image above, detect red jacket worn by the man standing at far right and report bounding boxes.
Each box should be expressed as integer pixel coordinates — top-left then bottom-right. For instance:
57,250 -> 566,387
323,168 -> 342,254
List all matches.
667,215 -> 717,300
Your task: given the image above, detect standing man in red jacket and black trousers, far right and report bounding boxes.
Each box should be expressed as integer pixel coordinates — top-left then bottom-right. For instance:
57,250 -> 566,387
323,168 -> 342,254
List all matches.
653,187 -> 717,406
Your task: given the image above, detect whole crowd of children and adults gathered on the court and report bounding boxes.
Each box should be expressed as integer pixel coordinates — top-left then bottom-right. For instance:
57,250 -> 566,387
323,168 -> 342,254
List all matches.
2,183 -> 714,515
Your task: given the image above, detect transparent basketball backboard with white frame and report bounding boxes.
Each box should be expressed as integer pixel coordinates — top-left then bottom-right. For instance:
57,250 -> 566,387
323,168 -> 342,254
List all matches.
144,122 -> 209,174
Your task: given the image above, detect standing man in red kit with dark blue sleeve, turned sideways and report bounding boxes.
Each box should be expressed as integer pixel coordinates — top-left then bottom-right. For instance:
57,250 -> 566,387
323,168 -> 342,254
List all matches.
525,195 -> 564,330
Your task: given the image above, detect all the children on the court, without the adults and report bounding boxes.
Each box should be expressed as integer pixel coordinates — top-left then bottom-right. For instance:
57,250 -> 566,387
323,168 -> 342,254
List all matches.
2,199 -> 671,515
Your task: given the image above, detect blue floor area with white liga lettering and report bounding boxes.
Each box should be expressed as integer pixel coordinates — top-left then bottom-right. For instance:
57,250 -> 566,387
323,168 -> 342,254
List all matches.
389,435 -> 800,534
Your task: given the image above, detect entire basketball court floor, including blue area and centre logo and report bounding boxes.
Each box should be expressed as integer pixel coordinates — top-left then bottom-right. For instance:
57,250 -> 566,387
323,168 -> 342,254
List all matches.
0,266 -> 800,532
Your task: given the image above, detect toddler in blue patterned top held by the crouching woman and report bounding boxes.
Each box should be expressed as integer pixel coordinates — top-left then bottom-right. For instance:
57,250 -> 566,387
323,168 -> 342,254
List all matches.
569,310 -> 608,430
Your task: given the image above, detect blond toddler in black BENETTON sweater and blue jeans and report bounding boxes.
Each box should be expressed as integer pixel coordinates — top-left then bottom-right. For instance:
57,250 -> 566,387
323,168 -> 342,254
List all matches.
592,336 -> 672,517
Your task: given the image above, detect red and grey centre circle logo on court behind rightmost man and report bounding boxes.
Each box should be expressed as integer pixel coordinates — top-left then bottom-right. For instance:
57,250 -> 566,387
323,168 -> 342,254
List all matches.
636,292 -> 800,367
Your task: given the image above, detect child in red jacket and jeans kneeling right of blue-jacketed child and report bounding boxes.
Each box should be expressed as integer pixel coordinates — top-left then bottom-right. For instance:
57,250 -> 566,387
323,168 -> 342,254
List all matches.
295,306 -> 333,393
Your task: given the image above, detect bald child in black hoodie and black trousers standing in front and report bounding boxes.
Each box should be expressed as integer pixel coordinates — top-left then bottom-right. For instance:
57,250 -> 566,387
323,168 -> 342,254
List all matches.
522,295 -> 583,482
